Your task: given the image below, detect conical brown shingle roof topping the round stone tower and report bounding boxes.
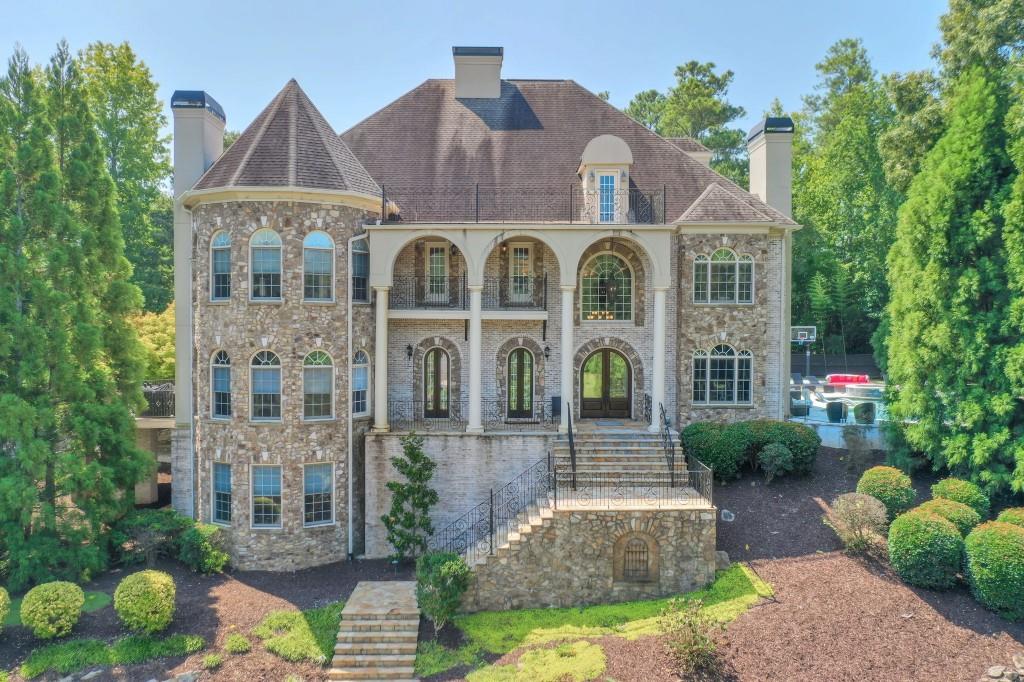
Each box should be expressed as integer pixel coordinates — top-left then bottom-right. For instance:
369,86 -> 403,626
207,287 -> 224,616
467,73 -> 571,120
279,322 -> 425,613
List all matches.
195,79 -> 381,197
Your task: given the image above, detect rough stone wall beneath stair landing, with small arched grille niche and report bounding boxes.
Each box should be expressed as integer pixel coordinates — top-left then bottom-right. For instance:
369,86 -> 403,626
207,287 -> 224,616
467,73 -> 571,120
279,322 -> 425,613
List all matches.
462,507 -> 716,612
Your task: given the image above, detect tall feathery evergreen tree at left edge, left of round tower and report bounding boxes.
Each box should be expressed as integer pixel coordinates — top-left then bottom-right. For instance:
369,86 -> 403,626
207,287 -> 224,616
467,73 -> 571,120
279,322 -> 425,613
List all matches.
0,44 -> 146,589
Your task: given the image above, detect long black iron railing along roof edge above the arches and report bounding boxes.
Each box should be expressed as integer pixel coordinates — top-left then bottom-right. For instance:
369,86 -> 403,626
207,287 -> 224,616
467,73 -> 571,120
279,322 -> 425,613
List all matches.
381,184 -> 667,224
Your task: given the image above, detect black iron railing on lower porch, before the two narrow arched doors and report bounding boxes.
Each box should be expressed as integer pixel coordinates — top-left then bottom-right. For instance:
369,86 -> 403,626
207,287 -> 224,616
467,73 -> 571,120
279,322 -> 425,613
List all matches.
387,400 -> 557,433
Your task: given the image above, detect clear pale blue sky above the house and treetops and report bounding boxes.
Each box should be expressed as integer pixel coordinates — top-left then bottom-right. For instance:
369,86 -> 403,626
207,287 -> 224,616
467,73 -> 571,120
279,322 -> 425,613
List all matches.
8,0 -> 946,138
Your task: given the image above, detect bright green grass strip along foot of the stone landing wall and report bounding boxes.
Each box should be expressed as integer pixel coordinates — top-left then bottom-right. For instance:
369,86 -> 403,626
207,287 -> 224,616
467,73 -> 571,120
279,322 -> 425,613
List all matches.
416,563 -> 772,677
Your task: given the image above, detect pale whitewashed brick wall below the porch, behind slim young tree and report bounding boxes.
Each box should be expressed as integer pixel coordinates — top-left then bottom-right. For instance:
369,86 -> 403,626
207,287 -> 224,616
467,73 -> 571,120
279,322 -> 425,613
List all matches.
366,433 -> 554,558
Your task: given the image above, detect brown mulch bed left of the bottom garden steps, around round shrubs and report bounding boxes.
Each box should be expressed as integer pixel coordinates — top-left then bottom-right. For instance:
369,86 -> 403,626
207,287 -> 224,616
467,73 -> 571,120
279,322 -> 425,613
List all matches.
0,560 -> 412,682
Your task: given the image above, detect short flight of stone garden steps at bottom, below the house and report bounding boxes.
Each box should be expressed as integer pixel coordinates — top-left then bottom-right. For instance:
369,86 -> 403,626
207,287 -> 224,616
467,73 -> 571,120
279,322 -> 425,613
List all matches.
328,581 -> 420,682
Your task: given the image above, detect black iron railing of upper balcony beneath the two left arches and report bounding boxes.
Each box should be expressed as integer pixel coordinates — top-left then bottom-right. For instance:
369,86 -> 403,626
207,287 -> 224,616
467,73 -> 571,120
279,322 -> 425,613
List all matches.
388,275 -> 548,310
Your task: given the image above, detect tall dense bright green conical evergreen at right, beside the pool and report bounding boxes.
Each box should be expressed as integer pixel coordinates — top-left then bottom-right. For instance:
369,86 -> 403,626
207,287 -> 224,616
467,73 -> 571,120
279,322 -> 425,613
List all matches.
888,67 -> 1024,493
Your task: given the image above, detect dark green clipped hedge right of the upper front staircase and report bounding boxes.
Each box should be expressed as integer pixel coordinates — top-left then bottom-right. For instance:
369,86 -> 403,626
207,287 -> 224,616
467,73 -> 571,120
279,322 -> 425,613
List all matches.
680,419 -> 821,480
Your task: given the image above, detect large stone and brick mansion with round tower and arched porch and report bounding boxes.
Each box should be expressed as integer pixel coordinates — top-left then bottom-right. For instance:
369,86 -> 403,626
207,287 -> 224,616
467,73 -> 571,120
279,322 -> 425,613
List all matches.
171,47 -> 799,570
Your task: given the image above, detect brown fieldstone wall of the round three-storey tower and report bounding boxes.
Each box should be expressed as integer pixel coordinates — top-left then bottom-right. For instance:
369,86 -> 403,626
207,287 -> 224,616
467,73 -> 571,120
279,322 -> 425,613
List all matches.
188,202 -> 374,570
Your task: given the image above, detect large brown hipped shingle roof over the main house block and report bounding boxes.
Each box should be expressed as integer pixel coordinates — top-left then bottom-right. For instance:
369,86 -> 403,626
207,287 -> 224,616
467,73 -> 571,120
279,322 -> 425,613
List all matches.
341,79 -> 795,224
